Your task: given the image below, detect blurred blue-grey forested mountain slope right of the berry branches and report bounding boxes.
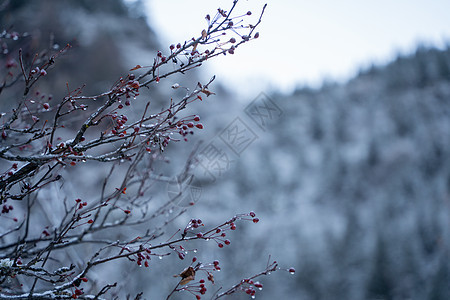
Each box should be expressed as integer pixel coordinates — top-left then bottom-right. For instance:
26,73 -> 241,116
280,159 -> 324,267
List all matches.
192,48 -> 450,299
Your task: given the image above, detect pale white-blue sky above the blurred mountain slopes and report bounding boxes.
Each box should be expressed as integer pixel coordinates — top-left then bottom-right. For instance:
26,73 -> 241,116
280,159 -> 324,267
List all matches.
143,0 -> 450,96
